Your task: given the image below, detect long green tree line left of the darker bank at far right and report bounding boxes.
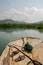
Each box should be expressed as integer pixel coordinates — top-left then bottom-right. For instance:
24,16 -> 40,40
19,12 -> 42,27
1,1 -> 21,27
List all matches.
0,24 -> 35,28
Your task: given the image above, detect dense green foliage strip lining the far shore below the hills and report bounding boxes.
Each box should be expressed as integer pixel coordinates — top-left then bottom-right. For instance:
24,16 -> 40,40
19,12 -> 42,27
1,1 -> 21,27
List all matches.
0,23 -> 43,29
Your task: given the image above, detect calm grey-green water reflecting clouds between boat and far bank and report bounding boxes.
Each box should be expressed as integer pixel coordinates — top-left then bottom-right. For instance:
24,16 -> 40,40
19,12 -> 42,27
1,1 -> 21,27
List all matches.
0,29 -> 43,54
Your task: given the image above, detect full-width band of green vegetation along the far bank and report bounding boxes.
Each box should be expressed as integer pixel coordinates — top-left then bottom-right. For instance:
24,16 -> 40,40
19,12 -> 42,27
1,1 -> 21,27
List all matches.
0,23 -> 43,31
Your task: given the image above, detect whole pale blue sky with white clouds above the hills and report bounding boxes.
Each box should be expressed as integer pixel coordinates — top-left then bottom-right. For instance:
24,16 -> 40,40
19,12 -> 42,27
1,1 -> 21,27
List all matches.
0,0 -> 43,23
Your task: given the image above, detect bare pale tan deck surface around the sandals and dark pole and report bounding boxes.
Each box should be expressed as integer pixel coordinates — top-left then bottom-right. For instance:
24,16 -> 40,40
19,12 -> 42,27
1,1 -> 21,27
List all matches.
0,37 -> 43,65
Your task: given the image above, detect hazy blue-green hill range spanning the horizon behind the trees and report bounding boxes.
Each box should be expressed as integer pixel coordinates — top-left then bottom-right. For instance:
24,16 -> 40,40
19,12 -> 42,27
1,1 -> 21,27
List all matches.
0,19 -> 43,24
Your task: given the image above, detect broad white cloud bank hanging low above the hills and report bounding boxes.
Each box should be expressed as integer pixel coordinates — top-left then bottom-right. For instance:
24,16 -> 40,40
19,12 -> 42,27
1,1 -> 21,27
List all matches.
0,7 -> 43,23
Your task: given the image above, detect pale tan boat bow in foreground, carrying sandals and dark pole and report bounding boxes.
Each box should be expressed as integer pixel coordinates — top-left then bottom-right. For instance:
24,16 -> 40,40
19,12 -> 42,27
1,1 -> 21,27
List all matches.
0,37 -> 43,65
